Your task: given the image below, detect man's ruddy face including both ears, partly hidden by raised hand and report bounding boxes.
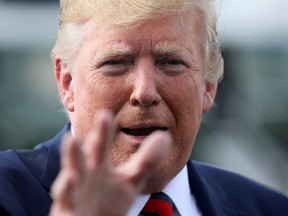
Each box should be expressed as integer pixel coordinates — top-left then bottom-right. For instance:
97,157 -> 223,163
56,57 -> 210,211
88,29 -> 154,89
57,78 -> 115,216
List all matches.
55,8 -> 217,193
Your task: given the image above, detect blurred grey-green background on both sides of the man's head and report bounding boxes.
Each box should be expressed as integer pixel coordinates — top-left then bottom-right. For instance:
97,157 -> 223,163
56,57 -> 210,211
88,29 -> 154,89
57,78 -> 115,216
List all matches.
0,0 -> 288,195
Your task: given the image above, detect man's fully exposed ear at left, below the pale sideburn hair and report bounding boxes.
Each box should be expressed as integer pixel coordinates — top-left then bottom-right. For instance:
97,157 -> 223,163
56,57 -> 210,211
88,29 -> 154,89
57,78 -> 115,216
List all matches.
54,58 -> 74,112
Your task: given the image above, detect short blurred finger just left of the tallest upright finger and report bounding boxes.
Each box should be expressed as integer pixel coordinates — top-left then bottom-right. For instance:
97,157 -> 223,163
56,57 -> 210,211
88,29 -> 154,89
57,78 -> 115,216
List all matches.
61,133 -> 84,176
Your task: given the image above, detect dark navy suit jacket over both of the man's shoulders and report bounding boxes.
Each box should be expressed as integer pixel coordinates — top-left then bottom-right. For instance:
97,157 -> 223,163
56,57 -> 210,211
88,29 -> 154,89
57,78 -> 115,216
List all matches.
0,124 -> 288,216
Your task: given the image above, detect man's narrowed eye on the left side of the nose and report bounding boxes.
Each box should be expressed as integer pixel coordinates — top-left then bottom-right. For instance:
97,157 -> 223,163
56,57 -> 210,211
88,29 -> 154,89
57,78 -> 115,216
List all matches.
99,59 -> 131,76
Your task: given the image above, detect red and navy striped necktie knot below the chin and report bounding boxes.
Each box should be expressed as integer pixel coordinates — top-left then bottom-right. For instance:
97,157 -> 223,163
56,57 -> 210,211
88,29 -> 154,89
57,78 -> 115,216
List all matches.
140,192 -> 173,216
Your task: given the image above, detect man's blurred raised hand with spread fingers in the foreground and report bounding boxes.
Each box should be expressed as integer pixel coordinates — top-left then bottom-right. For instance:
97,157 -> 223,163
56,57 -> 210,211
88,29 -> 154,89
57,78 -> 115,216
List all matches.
50,111 -> 171,216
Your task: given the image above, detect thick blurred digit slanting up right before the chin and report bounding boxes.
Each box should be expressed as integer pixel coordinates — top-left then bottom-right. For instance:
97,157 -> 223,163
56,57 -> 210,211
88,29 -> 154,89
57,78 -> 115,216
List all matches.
119,131 -> 172,187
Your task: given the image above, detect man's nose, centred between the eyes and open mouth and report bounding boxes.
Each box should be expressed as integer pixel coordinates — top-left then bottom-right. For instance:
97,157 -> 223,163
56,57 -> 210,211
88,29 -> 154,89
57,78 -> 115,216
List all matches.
130,68 -> 161,106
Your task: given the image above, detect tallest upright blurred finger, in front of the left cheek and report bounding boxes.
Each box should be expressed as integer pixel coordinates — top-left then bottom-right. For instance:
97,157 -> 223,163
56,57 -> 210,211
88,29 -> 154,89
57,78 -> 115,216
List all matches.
84,111 -> 115,170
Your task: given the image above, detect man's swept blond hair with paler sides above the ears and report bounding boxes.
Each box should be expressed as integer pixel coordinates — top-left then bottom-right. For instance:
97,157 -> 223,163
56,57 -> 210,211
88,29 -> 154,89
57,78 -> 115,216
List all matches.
51,0 -> 223,83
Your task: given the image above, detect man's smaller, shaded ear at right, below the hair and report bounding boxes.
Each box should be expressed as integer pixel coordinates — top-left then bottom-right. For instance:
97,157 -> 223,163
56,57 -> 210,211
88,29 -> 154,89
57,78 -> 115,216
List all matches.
202,82 -> 218,113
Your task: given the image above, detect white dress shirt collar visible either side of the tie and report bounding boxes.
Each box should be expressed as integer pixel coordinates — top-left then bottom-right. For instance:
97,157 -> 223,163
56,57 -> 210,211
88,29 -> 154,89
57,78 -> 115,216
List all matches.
127,166 -> 201,216
